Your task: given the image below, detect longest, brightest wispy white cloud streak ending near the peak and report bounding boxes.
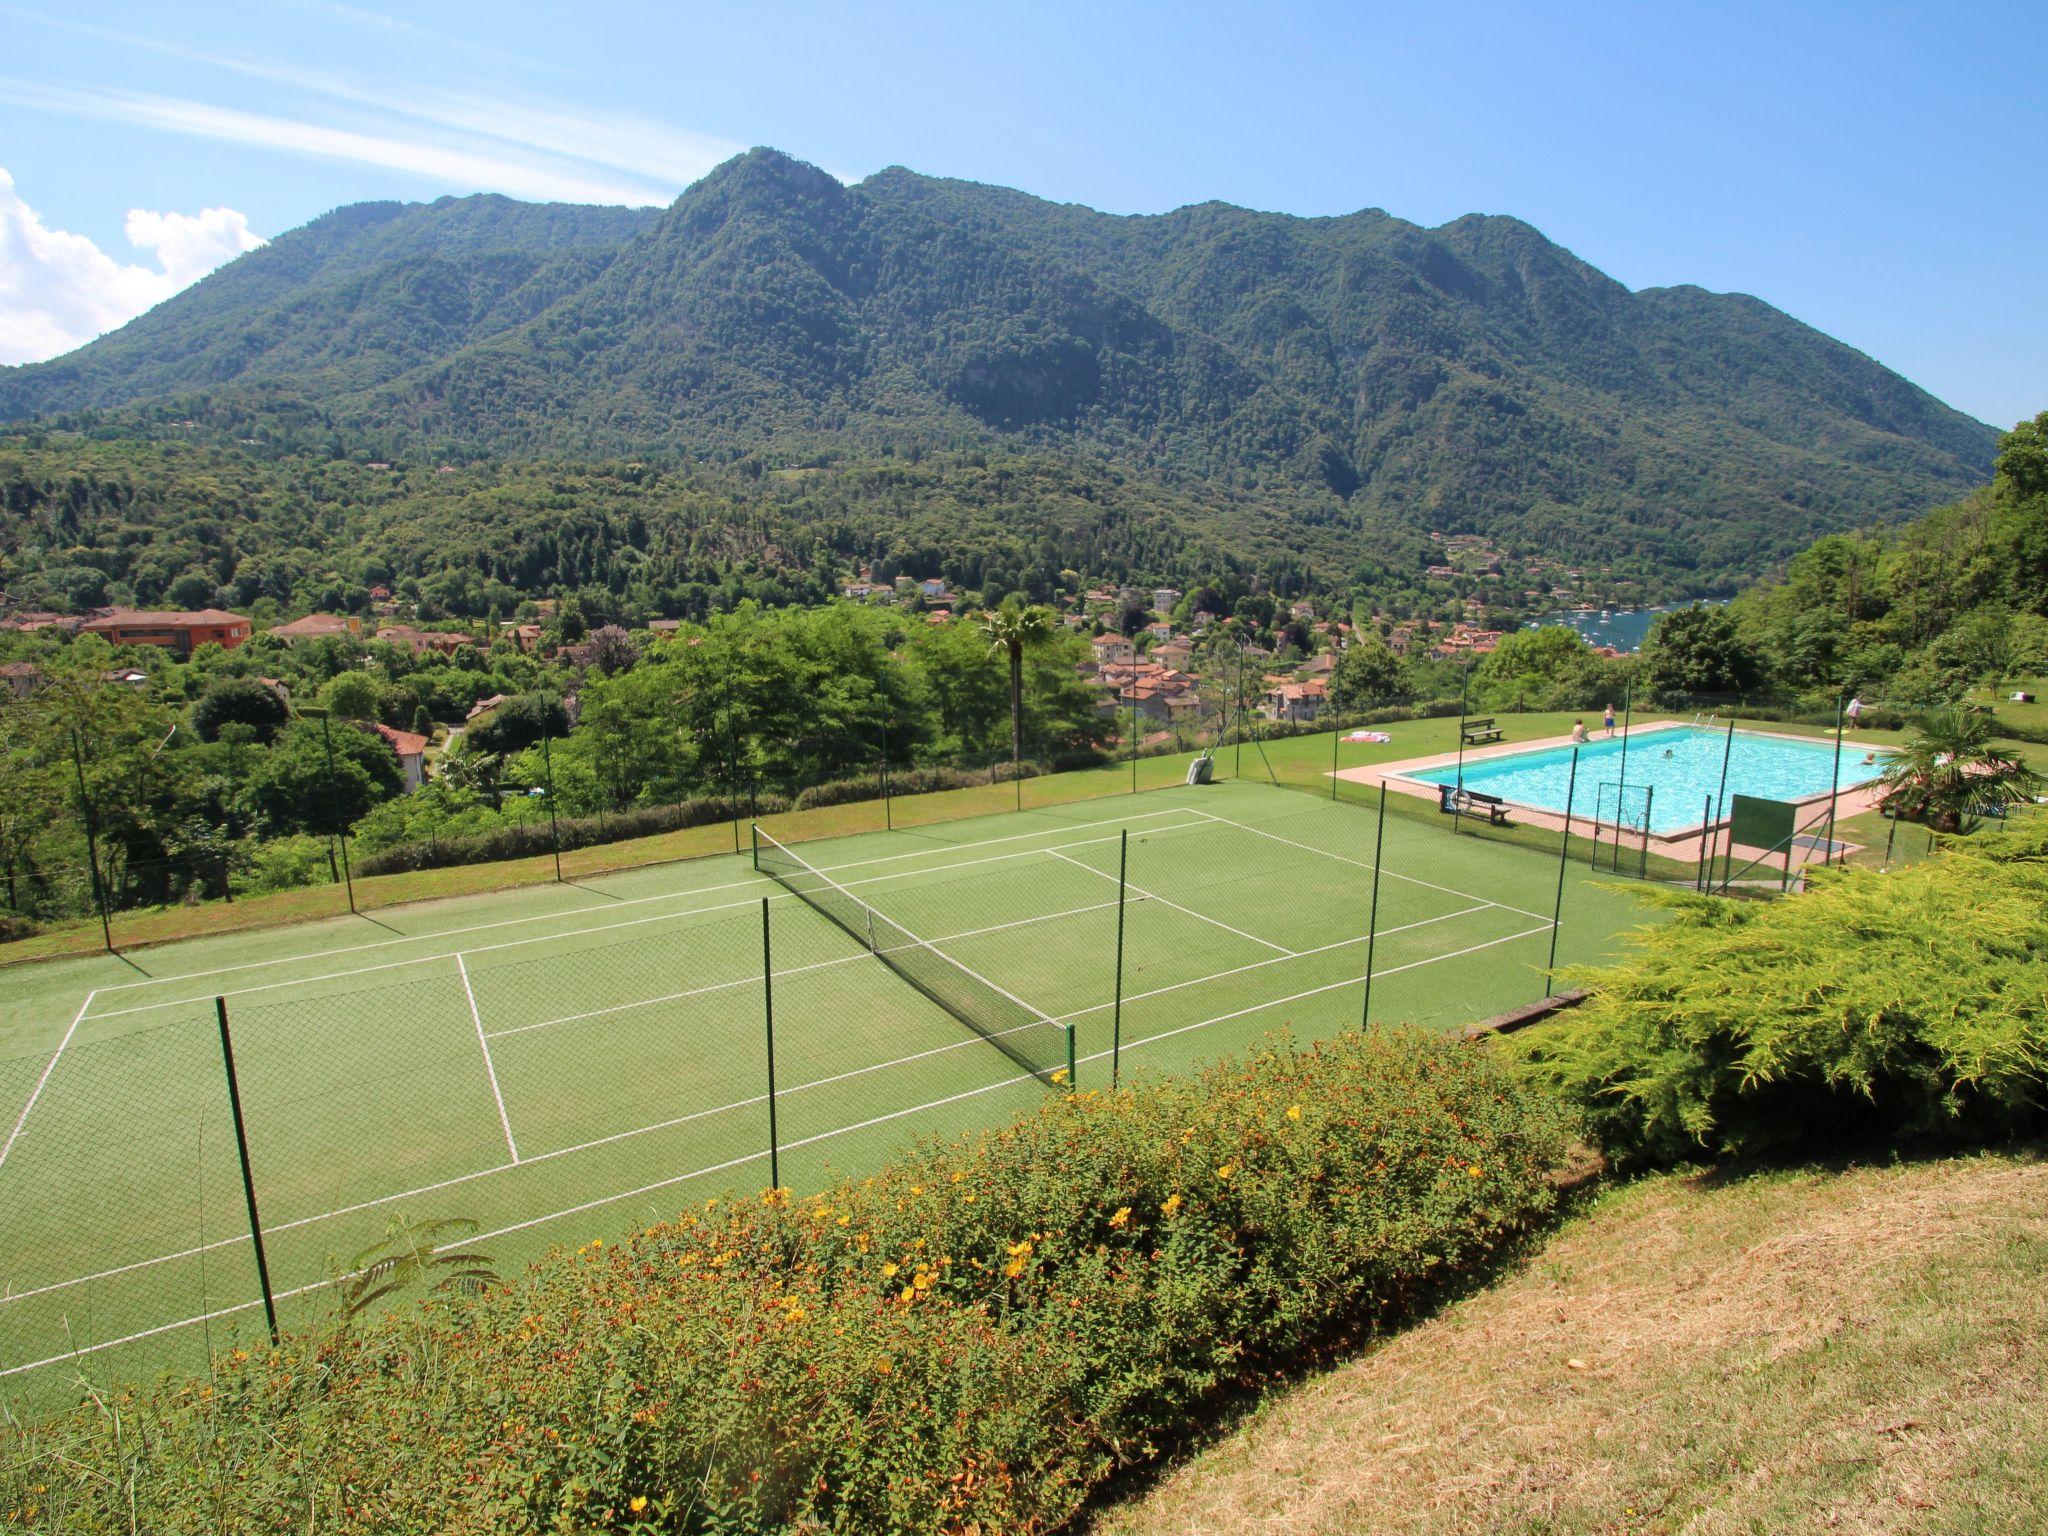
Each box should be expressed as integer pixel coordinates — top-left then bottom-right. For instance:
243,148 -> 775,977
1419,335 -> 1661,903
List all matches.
0,76 -> 674,205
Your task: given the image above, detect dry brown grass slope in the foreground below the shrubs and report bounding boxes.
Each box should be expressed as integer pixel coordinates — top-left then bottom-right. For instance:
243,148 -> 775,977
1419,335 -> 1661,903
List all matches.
1094,1157 -> 2048,1536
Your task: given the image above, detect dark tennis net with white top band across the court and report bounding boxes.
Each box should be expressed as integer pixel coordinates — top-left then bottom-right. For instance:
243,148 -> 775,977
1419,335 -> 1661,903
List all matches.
754,827 -> 1073,1085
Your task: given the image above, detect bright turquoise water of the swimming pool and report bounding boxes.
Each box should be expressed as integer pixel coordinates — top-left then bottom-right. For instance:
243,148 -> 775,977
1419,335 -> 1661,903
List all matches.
1403,725 -> 1884,831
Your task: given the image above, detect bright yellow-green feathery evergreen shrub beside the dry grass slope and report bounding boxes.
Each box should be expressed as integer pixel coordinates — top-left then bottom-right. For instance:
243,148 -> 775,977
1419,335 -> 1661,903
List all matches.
1513,815 -> 2048,1163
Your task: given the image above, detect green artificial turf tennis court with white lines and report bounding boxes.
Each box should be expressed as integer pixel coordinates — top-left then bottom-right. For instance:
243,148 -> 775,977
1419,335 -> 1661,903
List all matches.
0,782 -> 1640,1397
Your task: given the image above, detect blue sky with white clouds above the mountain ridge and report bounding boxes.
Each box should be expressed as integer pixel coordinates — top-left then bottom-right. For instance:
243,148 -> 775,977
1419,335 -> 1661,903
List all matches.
0,0 -> 2048,426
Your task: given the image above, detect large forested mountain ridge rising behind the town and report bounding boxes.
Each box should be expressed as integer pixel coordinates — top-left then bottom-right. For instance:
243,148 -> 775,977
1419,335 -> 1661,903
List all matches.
0,150 -> 1995,584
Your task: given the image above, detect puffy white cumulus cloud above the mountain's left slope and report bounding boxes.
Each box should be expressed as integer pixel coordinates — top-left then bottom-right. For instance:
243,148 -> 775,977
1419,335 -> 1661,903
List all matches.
0,168 -> 264,362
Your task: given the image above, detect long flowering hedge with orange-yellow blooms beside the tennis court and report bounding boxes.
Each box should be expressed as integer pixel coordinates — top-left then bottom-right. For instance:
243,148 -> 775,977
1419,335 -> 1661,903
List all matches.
0,1032 -> 1565,1532
